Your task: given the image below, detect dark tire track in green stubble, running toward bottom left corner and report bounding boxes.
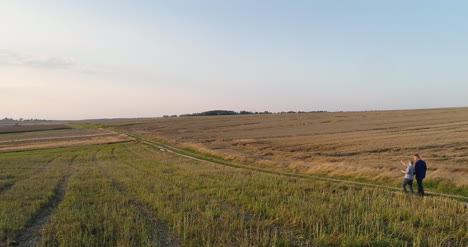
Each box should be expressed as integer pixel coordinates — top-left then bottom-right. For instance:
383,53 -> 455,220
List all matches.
13,155 -> 78,247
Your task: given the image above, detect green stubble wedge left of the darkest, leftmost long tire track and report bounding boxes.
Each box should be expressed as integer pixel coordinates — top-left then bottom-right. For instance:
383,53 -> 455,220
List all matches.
0,149 -> 74,245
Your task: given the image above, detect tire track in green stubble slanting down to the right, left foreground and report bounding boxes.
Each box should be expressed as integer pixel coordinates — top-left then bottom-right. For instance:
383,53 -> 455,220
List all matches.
93,148 -> 182,247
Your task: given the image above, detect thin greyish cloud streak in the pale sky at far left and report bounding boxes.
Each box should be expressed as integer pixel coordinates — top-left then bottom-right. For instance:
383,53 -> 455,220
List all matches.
0,50 -> 97,73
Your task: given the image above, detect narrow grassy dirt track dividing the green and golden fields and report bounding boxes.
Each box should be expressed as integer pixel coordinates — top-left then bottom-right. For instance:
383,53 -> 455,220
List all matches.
106,129 -> 468,203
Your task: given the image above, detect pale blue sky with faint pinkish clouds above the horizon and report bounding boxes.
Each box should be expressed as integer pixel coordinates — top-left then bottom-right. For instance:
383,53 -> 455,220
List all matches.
0,0 -> 468,120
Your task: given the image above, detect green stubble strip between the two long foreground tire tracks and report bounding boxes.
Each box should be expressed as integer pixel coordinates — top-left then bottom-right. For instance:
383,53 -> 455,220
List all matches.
41,149 -> 152,246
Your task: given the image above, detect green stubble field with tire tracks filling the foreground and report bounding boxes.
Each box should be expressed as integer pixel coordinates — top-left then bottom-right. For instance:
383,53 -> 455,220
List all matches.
0,140 -> 468,246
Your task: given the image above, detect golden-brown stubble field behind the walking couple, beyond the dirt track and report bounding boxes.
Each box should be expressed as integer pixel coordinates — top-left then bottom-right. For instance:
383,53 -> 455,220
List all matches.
102,108 -> 468,186
